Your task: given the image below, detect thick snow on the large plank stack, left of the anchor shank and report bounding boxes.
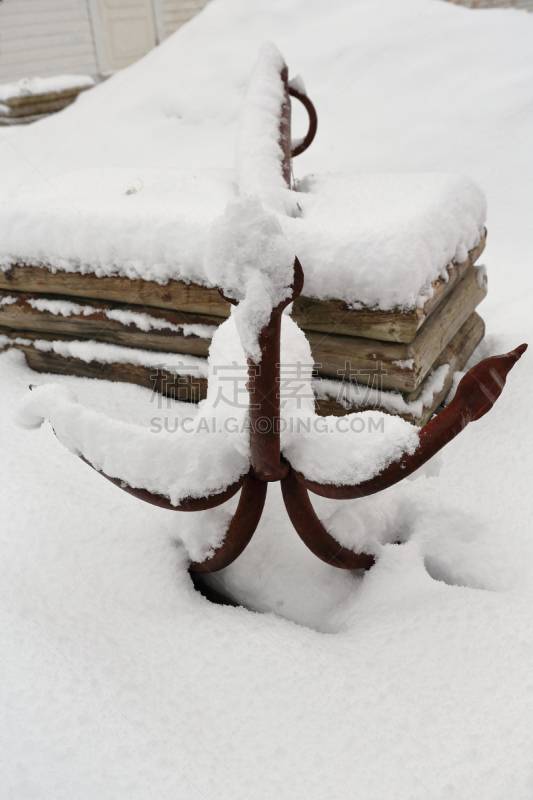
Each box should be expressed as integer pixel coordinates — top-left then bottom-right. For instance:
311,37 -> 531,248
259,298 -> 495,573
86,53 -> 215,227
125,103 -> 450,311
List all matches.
0,167 -> 237,283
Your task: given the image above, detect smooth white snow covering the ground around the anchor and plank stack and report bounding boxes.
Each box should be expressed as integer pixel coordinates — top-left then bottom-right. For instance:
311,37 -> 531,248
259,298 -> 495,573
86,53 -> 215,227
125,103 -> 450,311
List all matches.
0,0 -> 533,800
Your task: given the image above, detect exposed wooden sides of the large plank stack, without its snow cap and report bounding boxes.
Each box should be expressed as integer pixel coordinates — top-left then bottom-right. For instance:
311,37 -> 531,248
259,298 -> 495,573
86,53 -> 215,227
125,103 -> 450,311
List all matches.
0,230 -> 487,424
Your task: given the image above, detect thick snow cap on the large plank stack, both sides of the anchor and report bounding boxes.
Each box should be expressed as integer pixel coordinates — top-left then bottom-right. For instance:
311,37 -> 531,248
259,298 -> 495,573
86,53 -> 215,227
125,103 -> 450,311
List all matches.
0,167 -> 486,309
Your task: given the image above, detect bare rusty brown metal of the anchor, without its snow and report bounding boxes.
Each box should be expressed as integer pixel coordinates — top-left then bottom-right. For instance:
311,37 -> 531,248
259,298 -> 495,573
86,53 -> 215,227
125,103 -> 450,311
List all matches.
59,61 -> 527,580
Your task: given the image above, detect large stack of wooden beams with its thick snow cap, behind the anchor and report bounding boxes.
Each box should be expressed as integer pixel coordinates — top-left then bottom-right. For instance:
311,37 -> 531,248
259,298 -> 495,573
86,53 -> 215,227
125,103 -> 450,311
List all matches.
0,47 -> 486,424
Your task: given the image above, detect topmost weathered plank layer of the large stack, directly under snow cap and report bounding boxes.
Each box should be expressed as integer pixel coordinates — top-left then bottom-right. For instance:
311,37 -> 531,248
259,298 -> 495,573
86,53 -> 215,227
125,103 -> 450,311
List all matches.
0,236 -> 485,343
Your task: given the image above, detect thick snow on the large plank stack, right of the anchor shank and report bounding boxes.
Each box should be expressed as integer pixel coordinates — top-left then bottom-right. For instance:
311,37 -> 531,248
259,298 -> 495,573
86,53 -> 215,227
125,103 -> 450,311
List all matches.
284,173 -> 487,310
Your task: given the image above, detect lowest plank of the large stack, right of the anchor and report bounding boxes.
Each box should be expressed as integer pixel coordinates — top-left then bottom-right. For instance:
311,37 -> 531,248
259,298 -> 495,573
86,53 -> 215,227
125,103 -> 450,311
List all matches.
316,312 -> 485,427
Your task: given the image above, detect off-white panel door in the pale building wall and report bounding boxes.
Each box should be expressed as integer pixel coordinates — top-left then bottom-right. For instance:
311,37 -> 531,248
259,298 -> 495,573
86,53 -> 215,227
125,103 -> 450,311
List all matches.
98,0 -> 157,69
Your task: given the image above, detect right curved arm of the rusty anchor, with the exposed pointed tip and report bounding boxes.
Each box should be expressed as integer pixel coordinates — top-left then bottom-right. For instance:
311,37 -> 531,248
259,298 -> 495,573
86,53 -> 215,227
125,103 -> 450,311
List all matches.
295,344 -> 527,500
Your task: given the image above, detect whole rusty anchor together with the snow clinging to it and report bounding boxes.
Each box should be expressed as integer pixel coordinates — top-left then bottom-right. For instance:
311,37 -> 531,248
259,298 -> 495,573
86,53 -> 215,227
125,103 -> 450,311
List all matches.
17,42 -> 527,573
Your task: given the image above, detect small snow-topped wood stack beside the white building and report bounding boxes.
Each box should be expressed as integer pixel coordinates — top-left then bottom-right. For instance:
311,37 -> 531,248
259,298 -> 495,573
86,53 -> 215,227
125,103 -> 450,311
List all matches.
0,75 -> 94,125
